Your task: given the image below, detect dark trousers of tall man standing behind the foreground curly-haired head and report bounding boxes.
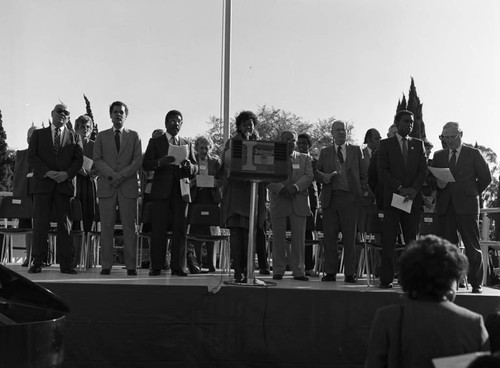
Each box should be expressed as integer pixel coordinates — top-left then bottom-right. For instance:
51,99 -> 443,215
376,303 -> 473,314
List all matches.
380,206 -> 422,284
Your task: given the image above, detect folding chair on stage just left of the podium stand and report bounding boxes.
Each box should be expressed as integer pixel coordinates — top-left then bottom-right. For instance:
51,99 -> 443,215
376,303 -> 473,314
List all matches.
186,203 -> 231,274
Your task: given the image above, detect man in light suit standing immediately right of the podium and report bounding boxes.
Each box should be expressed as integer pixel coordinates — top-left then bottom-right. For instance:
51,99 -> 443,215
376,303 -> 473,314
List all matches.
267,131 -> 314,281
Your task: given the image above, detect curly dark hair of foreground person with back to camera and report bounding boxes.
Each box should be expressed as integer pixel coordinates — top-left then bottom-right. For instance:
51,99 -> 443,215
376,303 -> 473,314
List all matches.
399,235 -> 469,300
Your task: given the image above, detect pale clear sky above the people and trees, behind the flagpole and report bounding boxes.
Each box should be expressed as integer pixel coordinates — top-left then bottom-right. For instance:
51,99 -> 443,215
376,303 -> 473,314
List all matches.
0,0 -> 500,160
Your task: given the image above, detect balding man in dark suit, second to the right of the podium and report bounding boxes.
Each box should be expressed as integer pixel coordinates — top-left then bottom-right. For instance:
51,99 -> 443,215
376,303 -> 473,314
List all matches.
316,120 -> 368,283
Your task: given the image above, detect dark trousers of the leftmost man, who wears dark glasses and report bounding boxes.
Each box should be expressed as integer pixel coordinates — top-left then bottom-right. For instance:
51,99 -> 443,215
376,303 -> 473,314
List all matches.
32,192 -> 73,268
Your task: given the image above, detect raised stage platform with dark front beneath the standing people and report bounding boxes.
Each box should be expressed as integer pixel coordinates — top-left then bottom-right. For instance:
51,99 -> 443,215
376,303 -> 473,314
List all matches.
7,265 -> 500,368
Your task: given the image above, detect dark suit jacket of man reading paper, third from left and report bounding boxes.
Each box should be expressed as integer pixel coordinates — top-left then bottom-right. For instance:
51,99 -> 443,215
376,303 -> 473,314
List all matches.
142,134 -> 198,199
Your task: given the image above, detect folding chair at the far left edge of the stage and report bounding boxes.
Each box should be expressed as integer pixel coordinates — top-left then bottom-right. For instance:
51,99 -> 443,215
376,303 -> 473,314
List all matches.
0,197 -> 33,263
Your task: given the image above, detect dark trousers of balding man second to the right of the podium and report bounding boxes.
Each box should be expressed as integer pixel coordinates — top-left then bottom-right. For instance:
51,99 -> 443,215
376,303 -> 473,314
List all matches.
323,191 -> 358,276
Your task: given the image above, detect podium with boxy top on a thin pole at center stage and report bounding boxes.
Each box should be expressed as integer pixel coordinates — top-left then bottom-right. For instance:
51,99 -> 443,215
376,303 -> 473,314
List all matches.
224,139 -> 290,286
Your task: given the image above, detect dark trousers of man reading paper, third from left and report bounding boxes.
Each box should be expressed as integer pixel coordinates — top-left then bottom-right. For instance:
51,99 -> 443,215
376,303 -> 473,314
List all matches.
151,191 -> 187,271
